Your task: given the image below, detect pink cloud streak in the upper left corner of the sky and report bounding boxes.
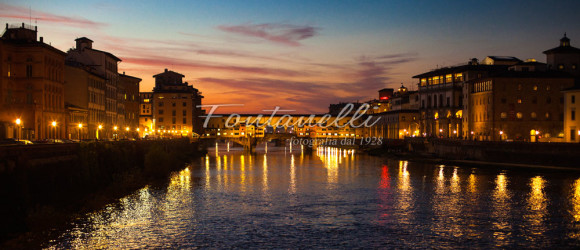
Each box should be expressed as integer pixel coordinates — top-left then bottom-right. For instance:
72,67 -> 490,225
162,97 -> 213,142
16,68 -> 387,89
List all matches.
0,3 -> 107,28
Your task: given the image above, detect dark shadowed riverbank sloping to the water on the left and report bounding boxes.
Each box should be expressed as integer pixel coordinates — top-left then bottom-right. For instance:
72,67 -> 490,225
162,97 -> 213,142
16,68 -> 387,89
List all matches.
0,139 -> 203,242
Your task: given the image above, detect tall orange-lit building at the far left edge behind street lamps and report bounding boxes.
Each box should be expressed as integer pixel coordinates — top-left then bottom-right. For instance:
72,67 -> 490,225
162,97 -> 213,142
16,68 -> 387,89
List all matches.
0,23 -> 66,140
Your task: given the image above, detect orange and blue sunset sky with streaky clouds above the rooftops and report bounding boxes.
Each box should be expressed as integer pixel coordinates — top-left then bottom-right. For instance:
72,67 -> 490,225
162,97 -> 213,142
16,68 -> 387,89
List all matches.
0,0 -> 580,113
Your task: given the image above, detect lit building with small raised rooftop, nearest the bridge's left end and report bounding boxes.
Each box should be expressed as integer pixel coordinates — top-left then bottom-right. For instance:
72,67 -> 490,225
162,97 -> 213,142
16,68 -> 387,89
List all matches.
152,69 -> 203,136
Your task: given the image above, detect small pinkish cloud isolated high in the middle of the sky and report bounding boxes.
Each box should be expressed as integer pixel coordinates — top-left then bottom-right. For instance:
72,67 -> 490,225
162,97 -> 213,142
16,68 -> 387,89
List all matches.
218,23 -> 317,46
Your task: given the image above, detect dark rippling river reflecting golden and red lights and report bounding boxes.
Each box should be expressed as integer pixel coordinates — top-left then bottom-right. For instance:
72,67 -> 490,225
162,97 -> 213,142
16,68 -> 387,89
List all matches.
45,148 -> 580,249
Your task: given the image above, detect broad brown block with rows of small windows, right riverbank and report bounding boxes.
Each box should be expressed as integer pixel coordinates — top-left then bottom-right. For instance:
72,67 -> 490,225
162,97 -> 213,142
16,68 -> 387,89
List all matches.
466,70 -> 574,142
